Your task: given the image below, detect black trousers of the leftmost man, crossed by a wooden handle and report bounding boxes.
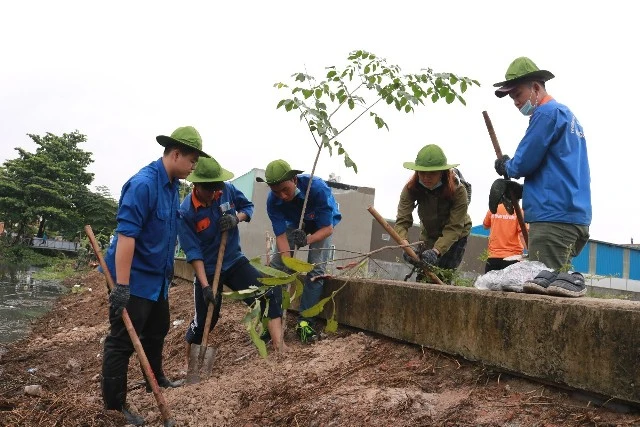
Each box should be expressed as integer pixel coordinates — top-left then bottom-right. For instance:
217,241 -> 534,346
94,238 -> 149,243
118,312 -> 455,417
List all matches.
102,293 -> 169,378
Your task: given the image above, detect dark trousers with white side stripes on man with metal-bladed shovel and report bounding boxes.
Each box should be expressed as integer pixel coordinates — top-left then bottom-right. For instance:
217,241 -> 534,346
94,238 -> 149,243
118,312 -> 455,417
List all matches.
185,257 -> 282,345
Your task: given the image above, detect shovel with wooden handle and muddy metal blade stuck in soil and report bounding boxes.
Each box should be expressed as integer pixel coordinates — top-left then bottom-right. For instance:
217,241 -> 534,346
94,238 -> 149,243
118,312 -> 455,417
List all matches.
187,231 -> 227,384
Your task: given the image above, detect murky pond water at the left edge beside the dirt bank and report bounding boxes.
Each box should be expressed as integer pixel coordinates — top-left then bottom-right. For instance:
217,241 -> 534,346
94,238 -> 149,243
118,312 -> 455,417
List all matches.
0,266 -> 66,353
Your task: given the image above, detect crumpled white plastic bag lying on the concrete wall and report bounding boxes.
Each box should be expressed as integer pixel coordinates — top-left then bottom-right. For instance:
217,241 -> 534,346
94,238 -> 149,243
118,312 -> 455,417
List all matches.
473,261 -> 553,292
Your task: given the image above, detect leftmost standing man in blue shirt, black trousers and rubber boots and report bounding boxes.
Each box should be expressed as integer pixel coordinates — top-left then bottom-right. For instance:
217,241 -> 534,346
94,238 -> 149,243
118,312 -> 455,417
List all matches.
102,126 -> 209,425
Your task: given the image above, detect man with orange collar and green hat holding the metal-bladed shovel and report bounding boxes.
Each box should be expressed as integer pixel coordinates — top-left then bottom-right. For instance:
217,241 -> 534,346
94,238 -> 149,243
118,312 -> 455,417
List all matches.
178,158 -> 284,360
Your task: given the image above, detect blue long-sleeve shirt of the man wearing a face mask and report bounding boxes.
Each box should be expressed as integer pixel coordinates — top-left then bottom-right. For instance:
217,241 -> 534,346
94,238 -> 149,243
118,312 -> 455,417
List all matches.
506,99 -> 591,225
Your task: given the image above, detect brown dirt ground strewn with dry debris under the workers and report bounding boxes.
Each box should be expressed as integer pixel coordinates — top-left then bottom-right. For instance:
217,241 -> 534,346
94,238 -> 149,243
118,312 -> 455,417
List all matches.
0,272 -> 640,426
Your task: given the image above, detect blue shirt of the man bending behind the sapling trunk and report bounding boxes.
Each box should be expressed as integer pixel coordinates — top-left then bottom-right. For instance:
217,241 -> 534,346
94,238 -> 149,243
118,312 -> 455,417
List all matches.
267,175 -> 342,236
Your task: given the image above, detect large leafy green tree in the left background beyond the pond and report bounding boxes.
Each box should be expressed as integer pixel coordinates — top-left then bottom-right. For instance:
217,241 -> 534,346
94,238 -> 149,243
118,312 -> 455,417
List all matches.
0,131 -> 117,241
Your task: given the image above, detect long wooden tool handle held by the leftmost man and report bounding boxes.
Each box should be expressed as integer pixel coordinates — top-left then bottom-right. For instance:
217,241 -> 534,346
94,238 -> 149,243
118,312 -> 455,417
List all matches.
84,225 -> 174,425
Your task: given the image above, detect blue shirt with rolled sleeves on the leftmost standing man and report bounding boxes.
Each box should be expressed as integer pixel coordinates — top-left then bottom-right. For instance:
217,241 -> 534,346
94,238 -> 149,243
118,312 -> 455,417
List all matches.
105,158 -> 179,301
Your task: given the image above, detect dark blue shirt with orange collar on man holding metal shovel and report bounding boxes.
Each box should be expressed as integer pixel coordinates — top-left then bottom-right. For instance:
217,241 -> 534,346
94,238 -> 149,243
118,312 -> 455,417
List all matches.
178,182 -> 253,276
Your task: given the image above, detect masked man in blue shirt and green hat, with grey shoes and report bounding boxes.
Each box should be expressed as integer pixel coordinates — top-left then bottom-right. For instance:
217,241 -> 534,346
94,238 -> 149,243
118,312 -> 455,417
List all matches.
494,57 -> 591,297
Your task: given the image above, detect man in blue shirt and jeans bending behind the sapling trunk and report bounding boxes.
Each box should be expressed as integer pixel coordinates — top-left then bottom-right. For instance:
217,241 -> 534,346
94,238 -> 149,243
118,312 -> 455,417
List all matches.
256,159 -> 342,342
